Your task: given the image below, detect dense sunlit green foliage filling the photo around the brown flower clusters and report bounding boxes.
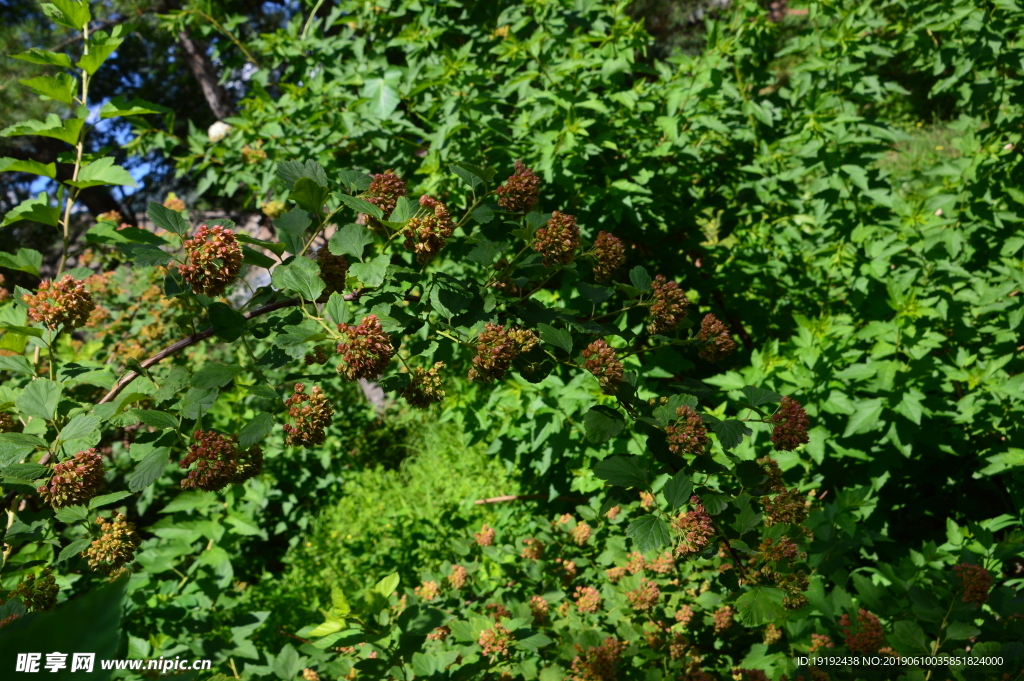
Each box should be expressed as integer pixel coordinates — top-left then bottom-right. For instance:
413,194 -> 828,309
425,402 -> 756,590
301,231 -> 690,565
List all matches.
0,0 -> 1024,681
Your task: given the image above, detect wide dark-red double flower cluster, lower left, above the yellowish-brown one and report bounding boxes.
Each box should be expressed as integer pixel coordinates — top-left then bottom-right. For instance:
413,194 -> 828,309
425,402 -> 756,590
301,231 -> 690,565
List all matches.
179,430 -> 263,492
